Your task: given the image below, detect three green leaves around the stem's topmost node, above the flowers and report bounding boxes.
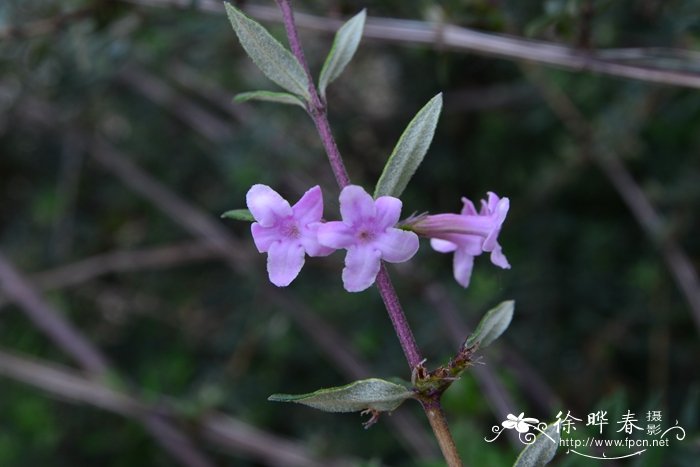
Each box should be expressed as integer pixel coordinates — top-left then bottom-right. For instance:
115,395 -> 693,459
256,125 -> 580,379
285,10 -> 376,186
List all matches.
224,3 -> 367,108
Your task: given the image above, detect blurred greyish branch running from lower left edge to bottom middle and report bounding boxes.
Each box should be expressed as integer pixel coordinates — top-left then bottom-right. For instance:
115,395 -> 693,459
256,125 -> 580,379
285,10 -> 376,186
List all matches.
0,350 -> 354,467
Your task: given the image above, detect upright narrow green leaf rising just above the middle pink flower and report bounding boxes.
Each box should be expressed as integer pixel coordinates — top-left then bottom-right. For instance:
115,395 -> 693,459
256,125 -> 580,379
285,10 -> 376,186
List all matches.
374,93 -> 442,198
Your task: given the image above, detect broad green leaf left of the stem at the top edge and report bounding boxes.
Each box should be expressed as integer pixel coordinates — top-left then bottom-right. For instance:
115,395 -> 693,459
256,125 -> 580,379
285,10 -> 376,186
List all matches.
224,3 -> 310,101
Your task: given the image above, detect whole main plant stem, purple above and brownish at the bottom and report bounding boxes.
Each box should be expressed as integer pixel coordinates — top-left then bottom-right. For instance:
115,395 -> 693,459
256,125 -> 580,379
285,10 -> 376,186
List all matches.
276,0 -> 462,467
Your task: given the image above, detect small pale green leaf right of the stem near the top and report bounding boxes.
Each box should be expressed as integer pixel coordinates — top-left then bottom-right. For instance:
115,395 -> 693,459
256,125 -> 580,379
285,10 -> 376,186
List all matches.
318,10 -> 367,100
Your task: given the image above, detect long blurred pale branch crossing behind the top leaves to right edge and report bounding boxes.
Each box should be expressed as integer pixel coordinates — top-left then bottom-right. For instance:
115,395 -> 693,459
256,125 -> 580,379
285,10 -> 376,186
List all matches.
122,0 -> 700,88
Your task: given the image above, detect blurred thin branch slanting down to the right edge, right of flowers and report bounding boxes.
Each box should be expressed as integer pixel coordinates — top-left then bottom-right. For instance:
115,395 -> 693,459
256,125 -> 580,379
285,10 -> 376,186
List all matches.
526,70 -> 700,332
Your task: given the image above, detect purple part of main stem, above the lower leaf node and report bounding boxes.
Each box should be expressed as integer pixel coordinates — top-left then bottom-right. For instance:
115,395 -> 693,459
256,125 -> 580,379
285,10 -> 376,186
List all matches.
276,0 -> 422,371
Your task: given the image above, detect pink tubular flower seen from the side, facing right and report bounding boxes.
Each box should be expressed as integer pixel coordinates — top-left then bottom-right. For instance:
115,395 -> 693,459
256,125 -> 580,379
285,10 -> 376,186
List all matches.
411,192 -> 510,287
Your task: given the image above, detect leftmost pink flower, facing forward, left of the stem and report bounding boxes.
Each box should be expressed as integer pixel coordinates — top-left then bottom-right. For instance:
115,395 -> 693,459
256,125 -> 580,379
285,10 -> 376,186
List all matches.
246,184 -> 333,287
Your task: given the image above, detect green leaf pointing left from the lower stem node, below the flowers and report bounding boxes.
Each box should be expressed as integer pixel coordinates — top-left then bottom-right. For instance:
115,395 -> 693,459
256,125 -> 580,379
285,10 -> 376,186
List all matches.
267,378 -> 413,412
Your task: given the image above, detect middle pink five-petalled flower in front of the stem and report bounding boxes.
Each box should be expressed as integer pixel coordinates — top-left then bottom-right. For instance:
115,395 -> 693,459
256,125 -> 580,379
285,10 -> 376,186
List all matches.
318,185 -> 418,292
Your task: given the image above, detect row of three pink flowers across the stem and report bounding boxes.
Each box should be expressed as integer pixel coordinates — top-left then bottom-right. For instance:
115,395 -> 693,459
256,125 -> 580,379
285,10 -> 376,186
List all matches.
246,184 -> 510,292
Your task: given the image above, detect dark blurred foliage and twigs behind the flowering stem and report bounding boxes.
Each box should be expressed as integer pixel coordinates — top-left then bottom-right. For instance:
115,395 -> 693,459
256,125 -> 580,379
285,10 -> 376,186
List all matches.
0,0 -> 700,467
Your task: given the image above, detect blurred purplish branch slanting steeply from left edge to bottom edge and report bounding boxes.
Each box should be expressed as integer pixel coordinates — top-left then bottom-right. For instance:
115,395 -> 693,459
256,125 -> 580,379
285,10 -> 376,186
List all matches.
0,252 -> 213,467
